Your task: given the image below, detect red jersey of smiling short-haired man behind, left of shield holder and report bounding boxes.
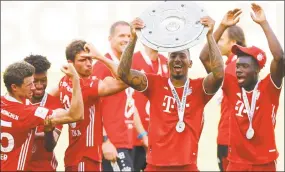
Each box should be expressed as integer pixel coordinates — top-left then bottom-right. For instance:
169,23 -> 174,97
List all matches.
93,54 -> 135,149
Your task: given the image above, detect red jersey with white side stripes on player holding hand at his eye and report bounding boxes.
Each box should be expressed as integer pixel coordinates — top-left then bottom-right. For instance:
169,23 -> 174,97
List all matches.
59,76 -> 103,167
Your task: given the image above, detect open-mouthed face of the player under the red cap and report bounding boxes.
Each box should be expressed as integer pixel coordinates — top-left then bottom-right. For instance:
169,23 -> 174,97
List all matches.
236,55 -> 259,88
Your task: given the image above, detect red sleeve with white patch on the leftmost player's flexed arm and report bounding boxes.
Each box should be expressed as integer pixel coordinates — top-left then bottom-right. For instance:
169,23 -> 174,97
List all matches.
21,105 -> 53,128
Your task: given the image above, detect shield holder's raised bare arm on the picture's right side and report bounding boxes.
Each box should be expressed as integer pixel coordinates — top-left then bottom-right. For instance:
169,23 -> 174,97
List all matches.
200,16 -> 224,94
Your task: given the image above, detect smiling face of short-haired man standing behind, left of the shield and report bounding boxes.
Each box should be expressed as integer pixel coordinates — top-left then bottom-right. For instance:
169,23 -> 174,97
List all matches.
109,25 -> 131,54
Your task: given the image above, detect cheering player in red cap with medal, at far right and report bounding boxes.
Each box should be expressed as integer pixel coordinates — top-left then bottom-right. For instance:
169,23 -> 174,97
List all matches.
222,3 -> 284,171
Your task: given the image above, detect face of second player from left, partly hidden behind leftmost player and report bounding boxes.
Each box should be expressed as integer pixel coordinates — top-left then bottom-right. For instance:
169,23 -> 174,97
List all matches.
33,72 -> 48,99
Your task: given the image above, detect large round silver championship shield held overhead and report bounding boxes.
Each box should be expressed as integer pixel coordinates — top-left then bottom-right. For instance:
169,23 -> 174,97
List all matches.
137,1 -> 208,52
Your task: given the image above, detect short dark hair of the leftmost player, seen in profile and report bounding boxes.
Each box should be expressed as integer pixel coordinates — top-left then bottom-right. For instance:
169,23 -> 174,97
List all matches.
3,61 -> 35,92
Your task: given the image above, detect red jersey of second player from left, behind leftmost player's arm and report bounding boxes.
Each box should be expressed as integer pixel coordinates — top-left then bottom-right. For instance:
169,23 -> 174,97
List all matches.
26,93 -> 63,171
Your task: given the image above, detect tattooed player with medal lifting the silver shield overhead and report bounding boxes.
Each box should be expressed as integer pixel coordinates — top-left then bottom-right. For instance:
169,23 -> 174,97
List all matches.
114,16 -> 224,171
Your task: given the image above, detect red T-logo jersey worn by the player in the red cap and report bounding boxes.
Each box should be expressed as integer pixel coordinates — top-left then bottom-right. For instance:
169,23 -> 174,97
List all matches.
223,74 -> 281,164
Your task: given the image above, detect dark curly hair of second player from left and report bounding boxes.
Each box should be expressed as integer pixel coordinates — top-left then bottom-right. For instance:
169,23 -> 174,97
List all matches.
24,54 -> 51,74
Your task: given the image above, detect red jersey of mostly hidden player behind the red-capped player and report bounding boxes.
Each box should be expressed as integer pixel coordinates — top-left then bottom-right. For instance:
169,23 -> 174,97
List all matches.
217,54 -> 237,145
